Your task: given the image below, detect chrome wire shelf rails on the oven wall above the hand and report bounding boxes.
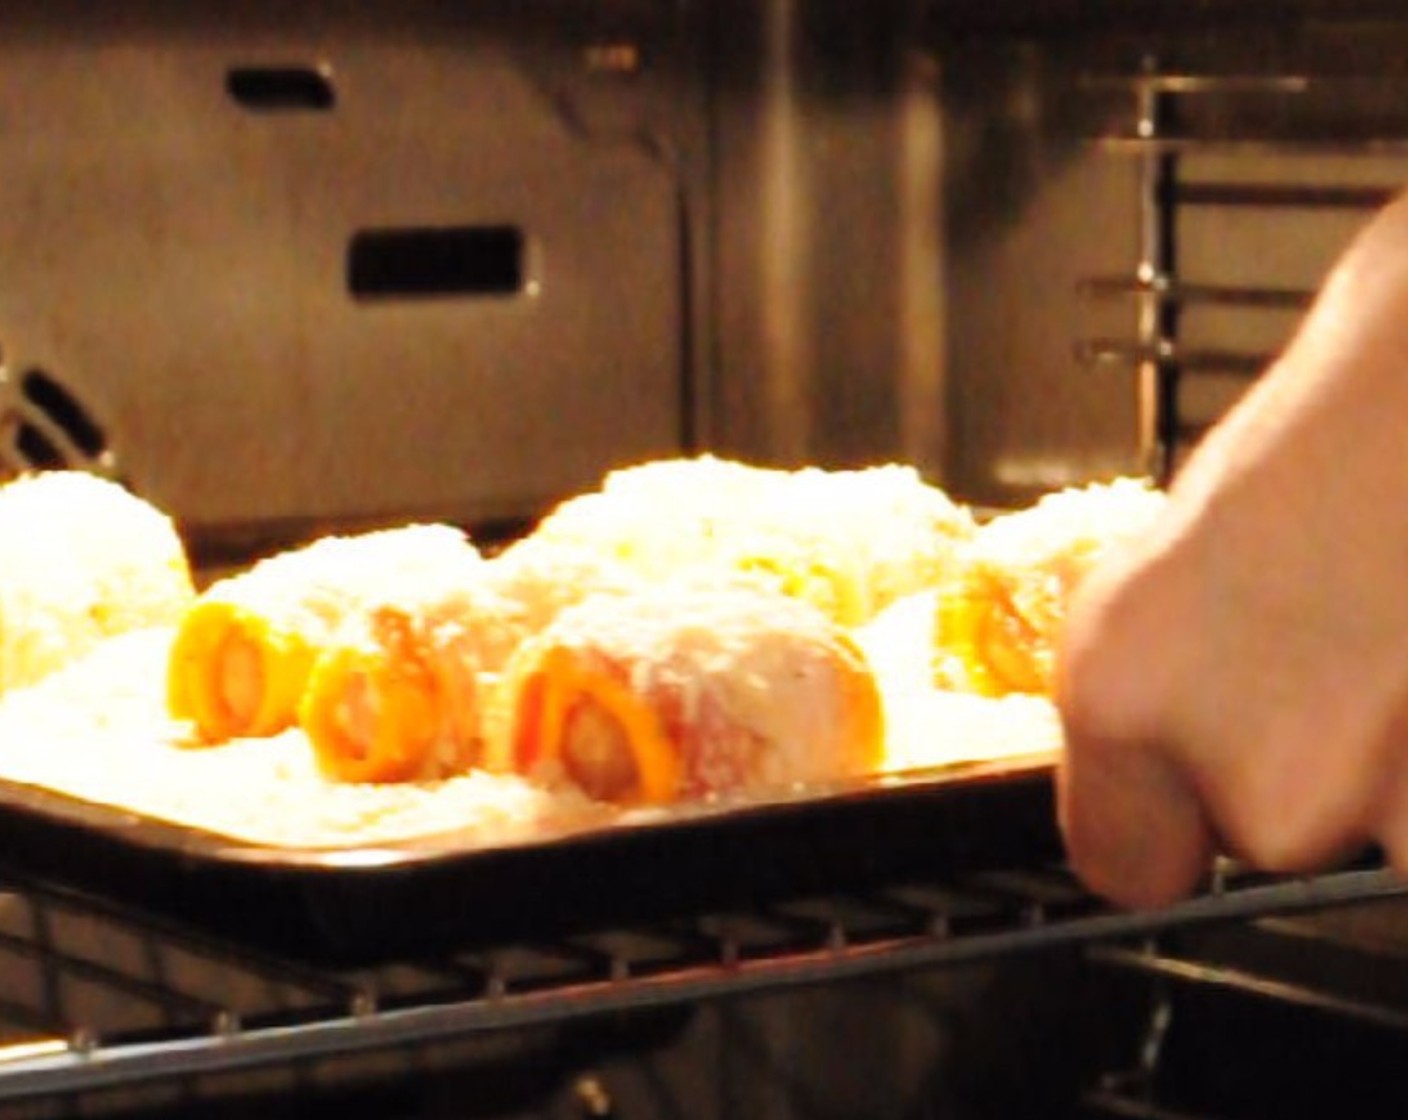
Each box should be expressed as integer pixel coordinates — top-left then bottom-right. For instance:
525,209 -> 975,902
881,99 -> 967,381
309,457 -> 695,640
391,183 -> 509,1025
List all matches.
1076,55 -> 1408,480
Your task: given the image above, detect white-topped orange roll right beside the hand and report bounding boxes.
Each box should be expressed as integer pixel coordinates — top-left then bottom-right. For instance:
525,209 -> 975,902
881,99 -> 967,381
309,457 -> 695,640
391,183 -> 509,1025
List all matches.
935,479 -> 1163,696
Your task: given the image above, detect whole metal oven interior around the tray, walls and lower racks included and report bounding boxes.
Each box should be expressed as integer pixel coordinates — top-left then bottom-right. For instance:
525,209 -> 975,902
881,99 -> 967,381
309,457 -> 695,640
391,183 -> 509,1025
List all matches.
0,0 -> 1408,1117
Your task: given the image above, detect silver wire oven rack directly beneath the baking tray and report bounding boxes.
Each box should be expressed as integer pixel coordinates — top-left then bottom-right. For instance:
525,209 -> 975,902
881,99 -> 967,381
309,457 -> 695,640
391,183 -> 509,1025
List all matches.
0,864 -> 1408,1114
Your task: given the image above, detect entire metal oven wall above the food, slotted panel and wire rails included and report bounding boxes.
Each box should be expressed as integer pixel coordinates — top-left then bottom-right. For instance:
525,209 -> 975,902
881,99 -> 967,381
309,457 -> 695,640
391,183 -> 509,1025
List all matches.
0,0 -> 1408,540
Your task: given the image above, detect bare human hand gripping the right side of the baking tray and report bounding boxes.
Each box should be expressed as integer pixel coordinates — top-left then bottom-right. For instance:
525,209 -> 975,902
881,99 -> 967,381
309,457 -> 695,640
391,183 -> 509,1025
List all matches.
1056,190 -> 1408,906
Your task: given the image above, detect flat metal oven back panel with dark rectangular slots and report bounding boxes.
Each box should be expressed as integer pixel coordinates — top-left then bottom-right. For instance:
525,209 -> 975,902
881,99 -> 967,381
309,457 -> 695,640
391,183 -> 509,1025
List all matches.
0,0 -> 689,552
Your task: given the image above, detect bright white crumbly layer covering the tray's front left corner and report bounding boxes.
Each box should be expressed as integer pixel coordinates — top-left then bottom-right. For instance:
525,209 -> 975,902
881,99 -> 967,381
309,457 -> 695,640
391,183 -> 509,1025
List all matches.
0,627 -> 582,848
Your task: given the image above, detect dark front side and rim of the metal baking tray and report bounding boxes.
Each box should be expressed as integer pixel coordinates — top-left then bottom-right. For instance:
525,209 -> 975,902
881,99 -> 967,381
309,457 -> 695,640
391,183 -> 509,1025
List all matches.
0,752 -> 1060,966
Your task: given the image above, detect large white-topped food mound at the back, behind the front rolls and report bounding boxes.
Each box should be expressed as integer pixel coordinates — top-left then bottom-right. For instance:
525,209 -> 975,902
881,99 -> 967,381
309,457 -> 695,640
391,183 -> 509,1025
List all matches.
532,455 -> 976,626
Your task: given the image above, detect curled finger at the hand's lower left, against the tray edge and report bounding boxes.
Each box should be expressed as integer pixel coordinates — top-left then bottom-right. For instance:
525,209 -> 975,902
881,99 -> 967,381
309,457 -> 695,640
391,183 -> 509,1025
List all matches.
1057,738 -> 1215,909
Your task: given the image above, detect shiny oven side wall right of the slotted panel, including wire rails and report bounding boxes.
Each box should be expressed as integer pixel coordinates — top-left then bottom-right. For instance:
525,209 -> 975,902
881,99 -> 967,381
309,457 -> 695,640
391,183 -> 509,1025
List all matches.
712,0 -> 1408,506
